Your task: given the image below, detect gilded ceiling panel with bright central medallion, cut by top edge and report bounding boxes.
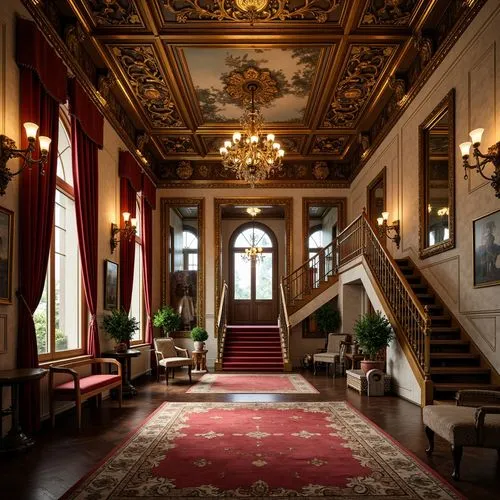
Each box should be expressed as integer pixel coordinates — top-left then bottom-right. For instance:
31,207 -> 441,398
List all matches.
163,0 -> 340,24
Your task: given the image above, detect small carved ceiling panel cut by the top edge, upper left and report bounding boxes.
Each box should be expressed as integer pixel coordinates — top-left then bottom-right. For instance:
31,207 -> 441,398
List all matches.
85,0 -> 144,27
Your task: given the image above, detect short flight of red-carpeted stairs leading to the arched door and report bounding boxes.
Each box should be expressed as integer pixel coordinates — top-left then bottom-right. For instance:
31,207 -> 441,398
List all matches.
222,325 -> 283,372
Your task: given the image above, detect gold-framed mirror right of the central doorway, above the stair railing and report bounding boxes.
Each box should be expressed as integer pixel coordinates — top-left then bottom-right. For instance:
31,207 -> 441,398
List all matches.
302,198 -> 347,262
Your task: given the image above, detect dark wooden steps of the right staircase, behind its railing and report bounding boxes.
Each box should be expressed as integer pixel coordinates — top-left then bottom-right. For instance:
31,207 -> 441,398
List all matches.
396,258 -> 498,400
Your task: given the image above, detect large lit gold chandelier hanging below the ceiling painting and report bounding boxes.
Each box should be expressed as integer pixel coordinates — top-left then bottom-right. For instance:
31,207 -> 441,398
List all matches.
219,83 -> 285,188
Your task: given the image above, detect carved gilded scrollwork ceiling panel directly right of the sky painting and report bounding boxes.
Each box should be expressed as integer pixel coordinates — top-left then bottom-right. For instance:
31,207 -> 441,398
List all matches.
324,45 -> 396,128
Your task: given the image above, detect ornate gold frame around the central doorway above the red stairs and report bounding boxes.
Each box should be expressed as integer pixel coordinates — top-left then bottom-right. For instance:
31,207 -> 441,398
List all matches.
214,197 -> 293,336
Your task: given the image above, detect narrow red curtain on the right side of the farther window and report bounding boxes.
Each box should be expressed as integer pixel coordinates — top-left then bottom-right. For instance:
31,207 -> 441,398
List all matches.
141,174 -> 156,368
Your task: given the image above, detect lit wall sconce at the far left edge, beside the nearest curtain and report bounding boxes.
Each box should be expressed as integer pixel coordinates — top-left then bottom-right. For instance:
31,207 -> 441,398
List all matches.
0,122 -> 51,196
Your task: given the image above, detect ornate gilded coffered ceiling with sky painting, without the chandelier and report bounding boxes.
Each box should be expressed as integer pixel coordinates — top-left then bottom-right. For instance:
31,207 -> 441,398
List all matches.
29,0 -> 484,187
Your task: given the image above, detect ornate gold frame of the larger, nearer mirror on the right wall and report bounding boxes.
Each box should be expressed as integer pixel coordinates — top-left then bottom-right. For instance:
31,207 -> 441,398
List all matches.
418,89 -> 455,259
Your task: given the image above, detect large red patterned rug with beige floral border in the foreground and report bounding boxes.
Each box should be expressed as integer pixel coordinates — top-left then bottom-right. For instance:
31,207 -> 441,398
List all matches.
63,402 -> 463,500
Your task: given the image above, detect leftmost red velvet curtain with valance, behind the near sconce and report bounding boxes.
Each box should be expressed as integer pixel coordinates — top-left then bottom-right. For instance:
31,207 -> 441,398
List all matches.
16,19 -> 66,432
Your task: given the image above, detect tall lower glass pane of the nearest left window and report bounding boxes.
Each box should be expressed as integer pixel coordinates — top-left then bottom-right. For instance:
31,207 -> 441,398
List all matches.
54,190 -> 81,352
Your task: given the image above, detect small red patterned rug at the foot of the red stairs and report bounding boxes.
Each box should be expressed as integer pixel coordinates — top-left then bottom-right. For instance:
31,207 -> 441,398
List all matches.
186,373 -> 319,394
